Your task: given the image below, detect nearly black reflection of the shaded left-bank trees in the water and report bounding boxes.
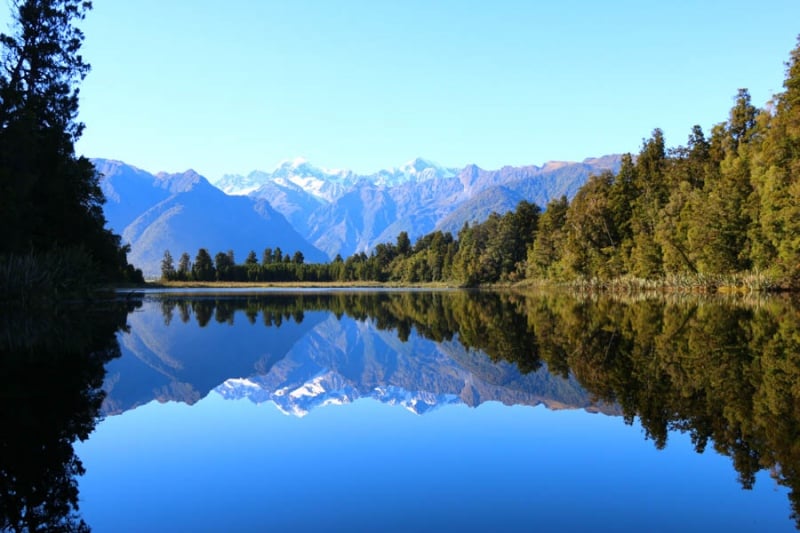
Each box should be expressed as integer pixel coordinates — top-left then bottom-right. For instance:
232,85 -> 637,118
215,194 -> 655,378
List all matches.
0,303 -> 130,531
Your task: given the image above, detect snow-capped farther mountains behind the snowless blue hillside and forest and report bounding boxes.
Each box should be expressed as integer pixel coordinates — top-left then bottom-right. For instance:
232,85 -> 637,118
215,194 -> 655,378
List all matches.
216,155 -> 620,258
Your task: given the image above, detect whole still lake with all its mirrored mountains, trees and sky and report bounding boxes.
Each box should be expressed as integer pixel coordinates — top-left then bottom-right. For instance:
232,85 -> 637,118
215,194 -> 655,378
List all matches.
0,290 -> 800,532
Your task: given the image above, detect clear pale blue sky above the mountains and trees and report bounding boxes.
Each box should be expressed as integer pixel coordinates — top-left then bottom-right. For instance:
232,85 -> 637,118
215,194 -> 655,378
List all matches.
10,0 -> 800,180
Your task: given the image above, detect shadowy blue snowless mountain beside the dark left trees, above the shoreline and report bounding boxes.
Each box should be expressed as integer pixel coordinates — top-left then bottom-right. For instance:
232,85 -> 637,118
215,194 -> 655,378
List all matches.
94,159 -> 327,277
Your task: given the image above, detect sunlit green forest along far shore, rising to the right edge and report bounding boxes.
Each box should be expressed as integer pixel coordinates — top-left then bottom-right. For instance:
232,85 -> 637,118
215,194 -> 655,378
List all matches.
162,40 -> 800,290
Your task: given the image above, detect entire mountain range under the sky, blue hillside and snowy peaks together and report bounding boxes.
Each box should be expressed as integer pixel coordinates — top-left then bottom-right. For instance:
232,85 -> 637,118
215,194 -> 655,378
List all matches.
93,155 -> 620,277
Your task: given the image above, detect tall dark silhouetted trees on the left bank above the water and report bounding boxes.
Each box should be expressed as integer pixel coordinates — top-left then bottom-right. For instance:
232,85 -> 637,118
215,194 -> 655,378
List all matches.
0,0 -> 133,279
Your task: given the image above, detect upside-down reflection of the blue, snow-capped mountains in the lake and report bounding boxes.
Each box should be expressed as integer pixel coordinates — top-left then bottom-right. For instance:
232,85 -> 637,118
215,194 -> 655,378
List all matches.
102,301 -> 618,417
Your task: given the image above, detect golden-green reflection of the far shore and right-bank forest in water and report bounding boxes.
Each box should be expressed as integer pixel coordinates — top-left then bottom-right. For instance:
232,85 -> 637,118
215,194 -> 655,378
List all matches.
153,291 -> 800,523
